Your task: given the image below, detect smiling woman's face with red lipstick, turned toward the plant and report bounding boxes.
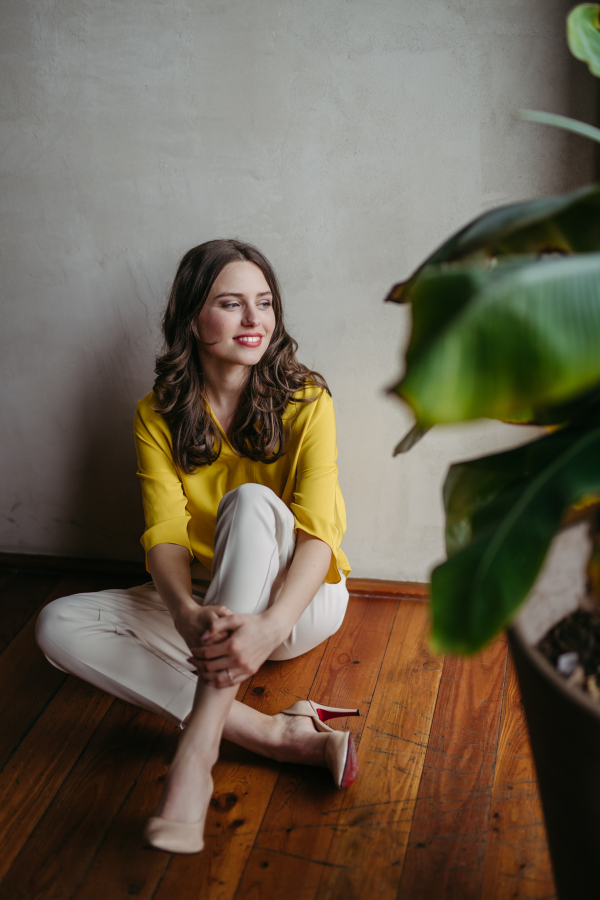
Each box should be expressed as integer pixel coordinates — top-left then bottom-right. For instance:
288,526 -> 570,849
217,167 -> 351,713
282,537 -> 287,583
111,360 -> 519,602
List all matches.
199,260 -> 276,366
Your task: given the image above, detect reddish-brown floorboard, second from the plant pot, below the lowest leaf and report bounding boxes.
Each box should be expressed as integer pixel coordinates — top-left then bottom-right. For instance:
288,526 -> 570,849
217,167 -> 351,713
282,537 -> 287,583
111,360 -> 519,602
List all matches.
399,639 -> 507,900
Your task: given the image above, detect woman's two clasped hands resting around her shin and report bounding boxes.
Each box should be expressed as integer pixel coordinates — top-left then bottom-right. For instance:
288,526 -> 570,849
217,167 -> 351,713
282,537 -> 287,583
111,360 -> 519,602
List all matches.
176,606 -> 287,687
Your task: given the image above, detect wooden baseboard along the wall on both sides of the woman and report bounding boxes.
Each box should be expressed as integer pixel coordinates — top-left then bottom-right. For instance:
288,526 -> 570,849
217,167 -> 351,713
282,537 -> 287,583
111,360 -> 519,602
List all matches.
0,553 -> 429,600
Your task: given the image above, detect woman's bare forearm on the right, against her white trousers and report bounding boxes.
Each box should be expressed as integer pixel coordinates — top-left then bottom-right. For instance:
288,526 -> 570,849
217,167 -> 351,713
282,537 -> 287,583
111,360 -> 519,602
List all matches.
263,530 -> 331,640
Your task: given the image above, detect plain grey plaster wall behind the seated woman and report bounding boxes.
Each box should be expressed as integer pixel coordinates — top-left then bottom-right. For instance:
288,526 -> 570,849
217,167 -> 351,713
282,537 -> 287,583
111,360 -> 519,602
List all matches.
0,0 -> 595,580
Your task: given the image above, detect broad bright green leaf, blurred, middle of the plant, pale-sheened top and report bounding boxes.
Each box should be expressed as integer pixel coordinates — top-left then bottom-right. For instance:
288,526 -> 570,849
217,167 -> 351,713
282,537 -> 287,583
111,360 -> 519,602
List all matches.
395,253 -> 600,428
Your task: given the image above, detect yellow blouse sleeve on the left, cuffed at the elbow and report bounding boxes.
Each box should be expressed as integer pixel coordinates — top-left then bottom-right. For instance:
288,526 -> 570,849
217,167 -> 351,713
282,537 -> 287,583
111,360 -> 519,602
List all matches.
135,400 -> 194,568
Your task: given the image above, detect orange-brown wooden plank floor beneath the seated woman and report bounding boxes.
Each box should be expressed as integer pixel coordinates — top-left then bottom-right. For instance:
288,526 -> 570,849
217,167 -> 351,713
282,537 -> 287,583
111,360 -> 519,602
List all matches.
0,572 -> 555,900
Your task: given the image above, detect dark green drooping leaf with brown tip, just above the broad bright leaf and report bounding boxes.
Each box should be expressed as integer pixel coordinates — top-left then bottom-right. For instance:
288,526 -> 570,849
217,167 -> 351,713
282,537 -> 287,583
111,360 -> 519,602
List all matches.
386,185 -> 600,303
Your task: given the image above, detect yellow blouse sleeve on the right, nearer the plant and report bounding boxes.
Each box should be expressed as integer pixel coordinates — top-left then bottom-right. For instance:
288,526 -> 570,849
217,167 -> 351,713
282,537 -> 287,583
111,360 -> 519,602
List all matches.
290,391 -> 345,584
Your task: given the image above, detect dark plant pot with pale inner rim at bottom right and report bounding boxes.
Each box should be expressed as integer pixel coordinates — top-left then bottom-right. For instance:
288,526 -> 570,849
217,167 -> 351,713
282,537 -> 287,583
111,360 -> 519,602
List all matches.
508,522 -> 600,900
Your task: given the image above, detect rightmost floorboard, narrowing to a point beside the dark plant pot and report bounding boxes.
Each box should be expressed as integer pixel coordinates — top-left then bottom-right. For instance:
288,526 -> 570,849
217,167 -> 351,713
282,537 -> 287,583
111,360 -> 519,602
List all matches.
481,654 -> 556,900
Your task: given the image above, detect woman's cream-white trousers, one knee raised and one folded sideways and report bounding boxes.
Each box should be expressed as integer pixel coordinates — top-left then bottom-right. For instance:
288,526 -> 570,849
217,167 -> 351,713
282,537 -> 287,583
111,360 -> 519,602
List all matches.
36,484 -> 348,724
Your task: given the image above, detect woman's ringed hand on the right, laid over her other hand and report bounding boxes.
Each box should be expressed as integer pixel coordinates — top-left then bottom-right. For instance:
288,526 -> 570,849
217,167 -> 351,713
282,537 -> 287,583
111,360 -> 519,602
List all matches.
189,607 -> 287,687
